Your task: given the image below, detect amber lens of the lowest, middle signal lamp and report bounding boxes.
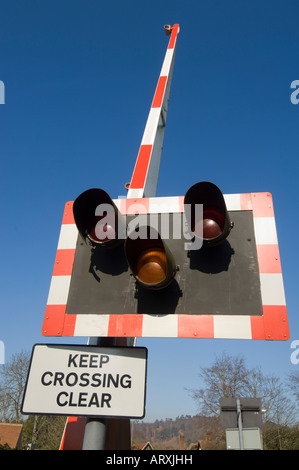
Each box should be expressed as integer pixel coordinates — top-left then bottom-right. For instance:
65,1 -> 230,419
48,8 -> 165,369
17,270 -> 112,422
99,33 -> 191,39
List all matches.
134,248 -> 167,284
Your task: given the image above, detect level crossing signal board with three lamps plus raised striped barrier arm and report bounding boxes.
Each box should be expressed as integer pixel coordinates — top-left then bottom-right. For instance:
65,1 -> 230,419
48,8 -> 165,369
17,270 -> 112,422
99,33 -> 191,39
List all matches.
43,24 -> 289,340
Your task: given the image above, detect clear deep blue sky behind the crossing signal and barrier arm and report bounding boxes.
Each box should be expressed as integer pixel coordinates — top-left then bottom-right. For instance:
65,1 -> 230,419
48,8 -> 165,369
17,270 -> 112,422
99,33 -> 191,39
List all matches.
0,0 -> 299,421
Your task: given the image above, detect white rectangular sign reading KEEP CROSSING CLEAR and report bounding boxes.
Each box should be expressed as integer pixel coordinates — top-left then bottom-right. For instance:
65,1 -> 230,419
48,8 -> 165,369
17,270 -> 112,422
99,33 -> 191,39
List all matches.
22,344 -> 147,418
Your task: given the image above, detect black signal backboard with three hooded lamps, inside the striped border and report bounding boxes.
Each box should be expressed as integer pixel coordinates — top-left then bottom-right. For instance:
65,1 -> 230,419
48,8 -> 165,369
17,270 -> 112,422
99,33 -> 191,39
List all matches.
66,181 -> 262,315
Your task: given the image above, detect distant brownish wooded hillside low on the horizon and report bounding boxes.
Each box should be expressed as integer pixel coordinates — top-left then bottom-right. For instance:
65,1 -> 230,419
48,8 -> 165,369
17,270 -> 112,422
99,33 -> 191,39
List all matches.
132,415 -> 226,450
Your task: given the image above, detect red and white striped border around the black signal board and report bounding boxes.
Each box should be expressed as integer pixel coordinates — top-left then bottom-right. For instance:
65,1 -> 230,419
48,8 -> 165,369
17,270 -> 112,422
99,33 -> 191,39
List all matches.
42,193 -> 289,340
